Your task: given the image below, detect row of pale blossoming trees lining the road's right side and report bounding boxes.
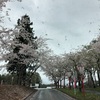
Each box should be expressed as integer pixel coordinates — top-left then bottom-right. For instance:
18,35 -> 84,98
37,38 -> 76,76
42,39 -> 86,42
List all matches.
43,36 -> 100,91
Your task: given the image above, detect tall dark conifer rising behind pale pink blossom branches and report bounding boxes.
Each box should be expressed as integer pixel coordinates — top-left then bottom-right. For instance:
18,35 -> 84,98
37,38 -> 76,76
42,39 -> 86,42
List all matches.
7,15 -> 37,85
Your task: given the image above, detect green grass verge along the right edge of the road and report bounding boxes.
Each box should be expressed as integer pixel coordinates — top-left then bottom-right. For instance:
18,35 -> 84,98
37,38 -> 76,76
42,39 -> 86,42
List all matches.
58,88 -> 100,100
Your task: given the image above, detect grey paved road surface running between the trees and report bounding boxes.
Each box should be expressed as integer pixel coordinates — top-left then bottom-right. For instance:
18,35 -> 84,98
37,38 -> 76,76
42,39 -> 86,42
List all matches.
26,89 -> 75,100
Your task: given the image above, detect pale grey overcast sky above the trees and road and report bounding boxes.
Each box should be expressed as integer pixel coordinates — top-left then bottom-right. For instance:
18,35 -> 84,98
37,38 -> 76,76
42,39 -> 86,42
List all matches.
2,0 -> 100,82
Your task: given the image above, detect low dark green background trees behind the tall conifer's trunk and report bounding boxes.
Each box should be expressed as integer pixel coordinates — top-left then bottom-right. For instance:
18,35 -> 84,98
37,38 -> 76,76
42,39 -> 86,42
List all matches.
0,72 -> 42,86
